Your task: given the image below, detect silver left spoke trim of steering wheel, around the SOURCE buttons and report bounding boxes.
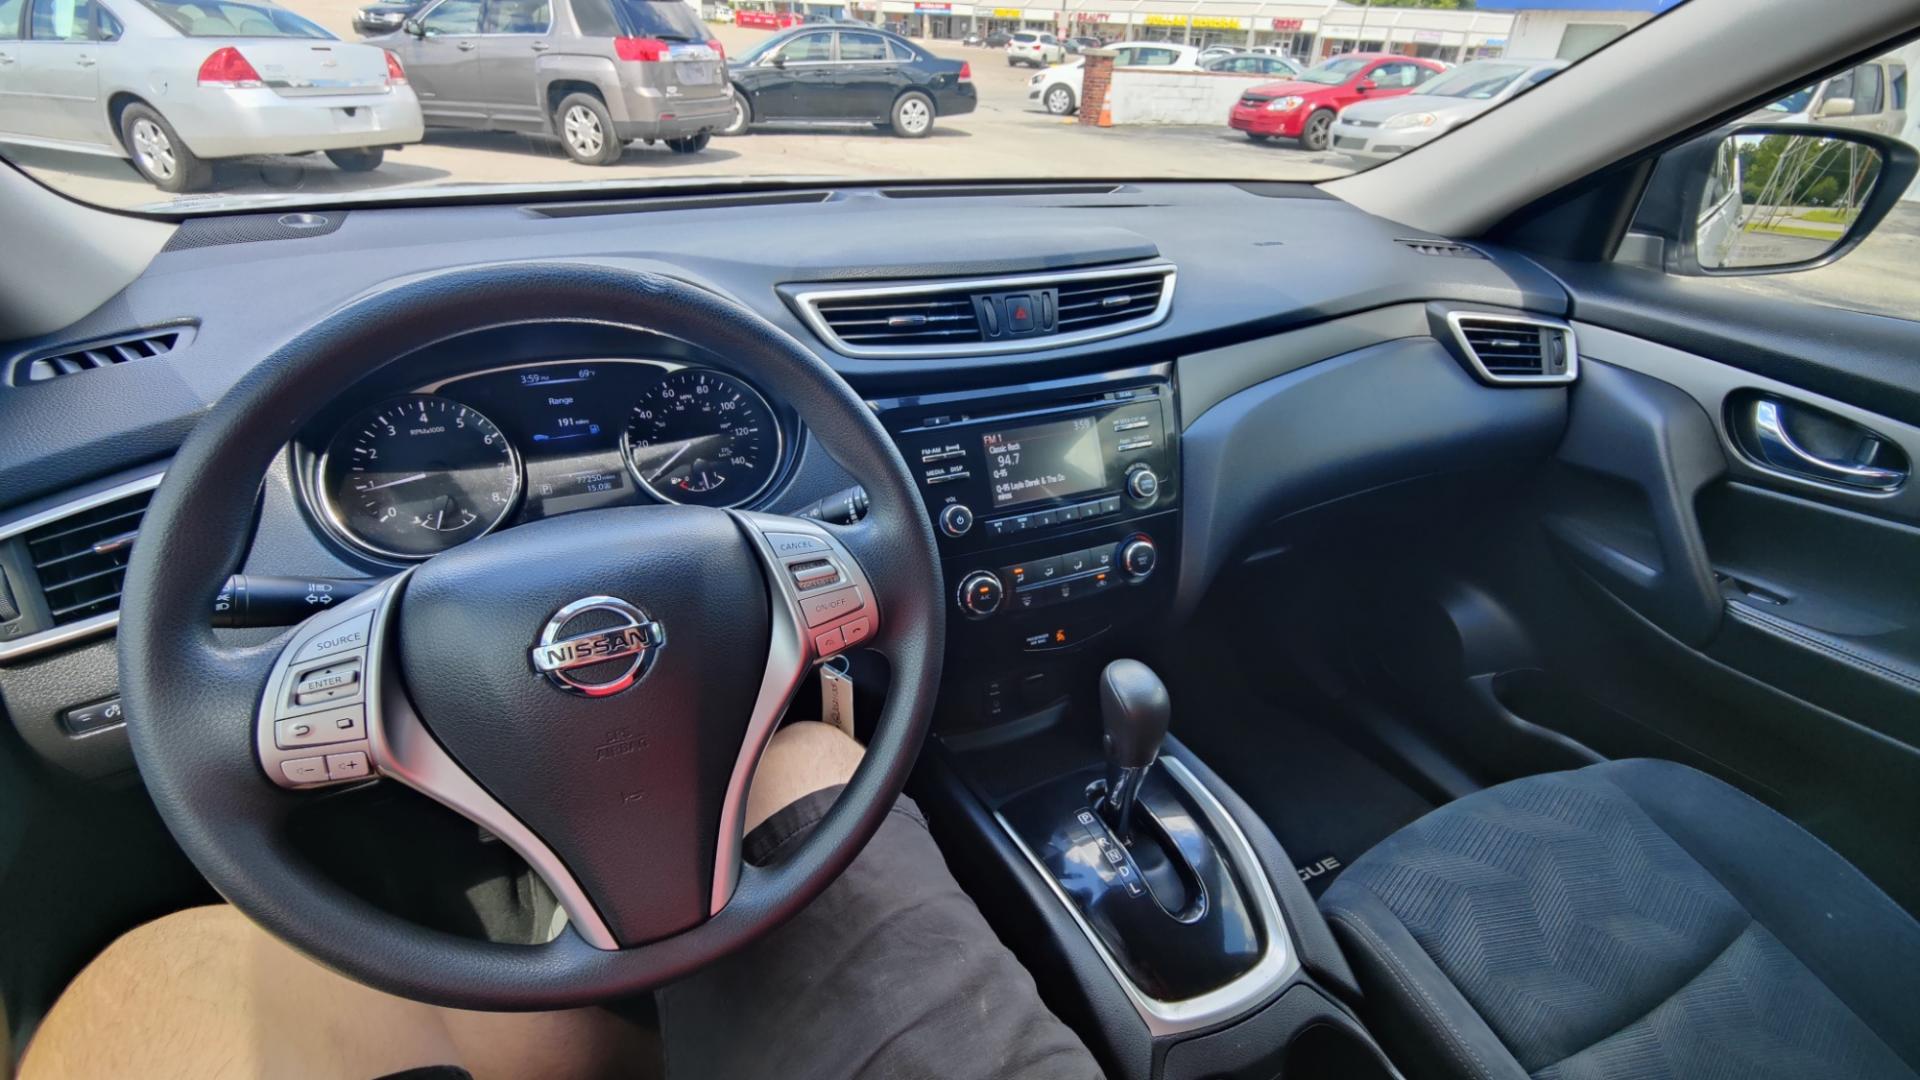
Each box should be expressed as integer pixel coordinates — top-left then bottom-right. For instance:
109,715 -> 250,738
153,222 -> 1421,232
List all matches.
255,571 -> 620,949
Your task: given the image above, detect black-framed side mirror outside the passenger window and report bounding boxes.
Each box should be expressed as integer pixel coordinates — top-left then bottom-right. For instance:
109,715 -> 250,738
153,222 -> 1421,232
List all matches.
1634,123 -> 1920,277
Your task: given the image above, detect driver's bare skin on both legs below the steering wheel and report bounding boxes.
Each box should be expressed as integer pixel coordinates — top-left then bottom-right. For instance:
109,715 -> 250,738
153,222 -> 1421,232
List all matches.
22,723 -> 864,1080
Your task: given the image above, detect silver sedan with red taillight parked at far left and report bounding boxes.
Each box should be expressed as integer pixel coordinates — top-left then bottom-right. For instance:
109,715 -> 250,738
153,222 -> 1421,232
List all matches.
0,0 -> 422,192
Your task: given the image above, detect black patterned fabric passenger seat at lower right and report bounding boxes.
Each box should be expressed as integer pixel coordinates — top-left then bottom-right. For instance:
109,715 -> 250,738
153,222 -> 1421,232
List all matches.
1321,761 -> 1920,1080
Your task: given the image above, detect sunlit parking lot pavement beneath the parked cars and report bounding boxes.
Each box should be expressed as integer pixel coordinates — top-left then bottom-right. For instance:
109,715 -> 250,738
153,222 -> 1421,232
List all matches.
8,15 -> 1348,208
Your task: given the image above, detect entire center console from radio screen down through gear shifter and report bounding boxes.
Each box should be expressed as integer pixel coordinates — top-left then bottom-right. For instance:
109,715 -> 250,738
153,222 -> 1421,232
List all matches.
872,363 -> 1394,1080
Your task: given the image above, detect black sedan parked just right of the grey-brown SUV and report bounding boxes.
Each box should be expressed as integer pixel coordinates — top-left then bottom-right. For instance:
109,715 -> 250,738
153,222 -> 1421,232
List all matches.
720,27 -> 975,138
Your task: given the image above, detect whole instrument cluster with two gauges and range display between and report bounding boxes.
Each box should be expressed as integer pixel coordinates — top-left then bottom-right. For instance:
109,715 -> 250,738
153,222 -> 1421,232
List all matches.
309,359 -> 785,561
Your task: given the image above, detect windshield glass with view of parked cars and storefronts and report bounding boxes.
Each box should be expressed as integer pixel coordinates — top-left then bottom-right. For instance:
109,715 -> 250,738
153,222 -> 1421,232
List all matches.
0,0 -> 1712,215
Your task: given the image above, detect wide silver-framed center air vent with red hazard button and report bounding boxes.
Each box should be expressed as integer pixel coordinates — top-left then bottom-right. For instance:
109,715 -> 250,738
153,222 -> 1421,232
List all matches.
781,263 -> 1173,359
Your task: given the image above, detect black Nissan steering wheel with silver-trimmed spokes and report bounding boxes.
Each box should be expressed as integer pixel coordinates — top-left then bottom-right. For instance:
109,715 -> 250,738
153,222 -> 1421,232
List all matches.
119,259 -> 945,1009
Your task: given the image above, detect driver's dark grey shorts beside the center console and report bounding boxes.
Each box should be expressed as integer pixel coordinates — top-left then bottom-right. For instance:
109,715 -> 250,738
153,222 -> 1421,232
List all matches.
659,788 -> 1100,1080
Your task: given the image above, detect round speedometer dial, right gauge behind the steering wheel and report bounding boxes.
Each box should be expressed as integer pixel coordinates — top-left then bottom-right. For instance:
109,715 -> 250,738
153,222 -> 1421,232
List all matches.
624,367 -> 780,505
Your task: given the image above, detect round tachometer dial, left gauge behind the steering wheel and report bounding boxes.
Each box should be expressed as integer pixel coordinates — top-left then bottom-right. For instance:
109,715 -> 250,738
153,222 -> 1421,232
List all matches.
321,394 -> 520,559
